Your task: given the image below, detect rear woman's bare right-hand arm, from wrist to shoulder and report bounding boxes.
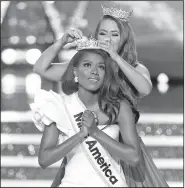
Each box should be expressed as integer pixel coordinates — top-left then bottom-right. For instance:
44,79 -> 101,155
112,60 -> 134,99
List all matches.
115,56 -> 152,97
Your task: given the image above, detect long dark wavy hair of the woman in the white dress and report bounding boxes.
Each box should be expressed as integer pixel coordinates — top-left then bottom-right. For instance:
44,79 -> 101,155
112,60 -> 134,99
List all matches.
62,49 -> 139,125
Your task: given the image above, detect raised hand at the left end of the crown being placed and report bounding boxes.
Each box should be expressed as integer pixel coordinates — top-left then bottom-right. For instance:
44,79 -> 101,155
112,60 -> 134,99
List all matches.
62,28 -> 83,44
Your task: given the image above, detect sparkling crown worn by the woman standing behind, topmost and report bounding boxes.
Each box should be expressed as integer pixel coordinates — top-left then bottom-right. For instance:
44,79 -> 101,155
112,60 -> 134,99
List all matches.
101,5 -> 133,22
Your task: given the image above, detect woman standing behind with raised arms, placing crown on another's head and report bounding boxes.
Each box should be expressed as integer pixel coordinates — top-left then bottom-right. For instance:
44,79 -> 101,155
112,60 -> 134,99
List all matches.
34,6 -> 152,103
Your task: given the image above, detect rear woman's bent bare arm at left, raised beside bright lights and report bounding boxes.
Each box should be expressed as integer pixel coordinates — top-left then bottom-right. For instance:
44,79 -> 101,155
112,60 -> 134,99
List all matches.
33,38 -> 68,82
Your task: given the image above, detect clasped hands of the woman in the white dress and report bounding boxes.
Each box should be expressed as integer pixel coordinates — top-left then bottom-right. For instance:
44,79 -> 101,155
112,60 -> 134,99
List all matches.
82,110 -> 98,135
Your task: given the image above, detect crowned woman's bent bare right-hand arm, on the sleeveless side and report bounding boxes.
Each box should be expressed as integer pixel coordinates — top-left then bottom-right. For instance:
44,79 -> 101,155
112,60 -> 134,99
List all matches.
91,101 -> 141,166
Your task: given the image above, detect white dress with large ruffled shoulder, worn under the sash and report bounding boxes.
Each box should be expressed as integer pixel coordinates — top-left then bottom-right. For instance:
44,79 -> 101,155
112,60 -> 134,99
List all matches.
30,90 -> 127,187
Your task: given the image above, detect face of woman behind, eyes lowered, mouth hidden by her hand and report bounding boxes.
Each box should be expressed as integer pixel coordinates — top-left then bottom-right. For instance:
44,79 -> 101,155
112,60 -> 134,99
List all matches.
97,19 -> 121,51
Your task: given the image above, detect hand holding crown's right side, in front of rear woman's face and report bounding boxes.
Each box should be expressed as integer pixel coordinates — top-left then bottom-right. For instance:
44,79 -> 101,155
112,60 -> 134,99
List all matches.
99,41 -> 119,61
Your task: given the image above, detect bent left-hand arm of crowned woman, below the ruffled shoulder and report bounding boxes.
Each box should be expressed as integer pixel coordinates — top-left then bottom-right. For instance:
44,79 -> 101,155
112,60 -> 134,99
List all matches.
38,123 -> 87,168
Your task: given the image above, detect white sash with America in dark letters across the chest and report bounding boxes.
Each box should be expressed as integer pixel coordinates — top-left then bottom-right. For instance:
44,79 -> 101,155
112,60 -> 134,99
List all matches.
61,93 -> 128,187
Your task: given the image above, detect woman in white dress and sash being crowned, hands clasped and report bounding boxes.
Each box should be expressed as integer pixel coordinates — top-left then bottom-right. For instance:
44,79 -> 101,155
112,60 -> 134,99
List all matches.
30,38 -> 167,187
